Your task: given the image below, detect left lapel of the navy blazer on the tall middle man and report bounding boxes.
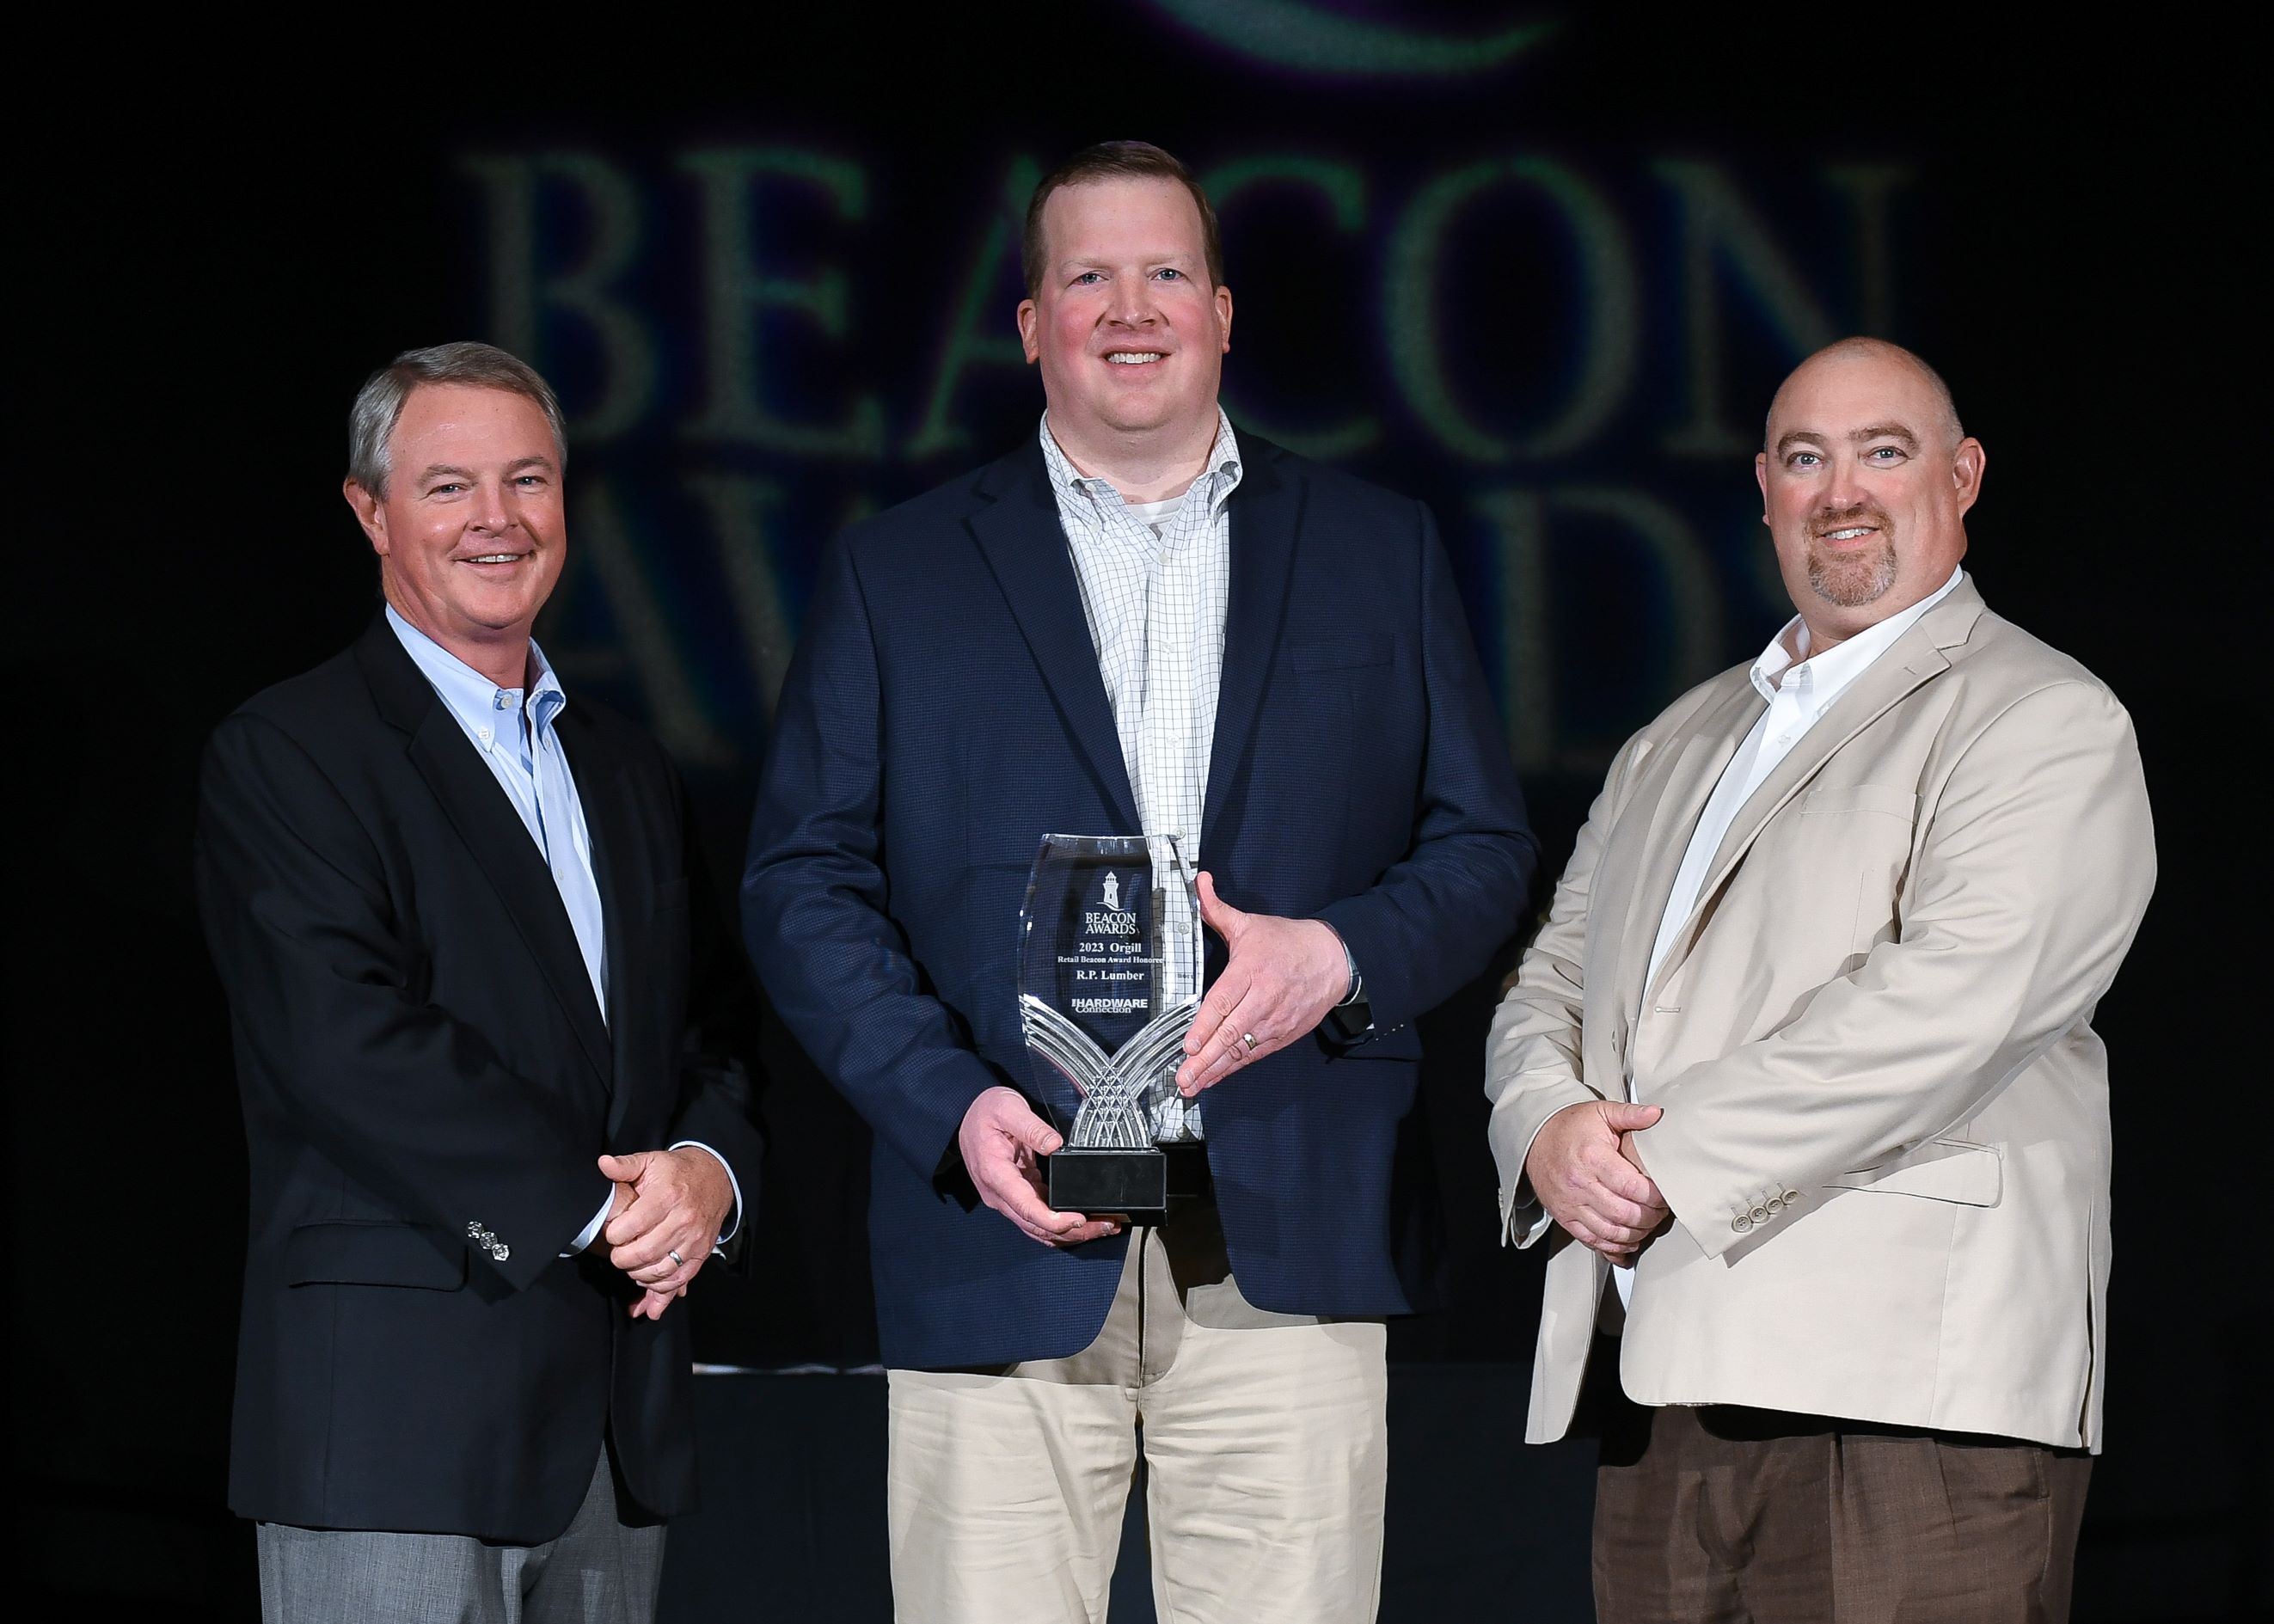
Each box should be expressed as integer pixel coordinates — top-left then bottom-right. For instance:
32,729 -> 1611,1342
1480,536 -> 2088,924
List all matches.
971,444 -> 1142,835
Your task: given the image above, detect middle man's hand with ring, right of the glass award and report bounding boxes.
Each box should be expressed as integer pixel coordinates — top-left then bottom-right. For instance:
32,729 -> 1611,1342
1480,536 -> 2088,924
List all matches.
1175,871 -> 1351,1099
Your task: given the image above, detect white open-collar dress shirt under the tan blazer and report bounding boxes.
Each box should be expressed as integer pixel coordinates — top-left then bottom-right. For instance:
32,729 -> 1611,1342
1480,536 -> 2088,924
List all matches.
1612,568 -> 1964,1303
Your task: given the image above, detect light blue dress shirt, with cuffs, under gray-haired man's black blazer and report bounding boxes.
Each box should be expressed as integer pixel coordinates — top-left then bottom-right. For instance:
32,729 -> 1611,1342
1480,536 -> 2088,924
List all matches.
387,603 -> 741,1258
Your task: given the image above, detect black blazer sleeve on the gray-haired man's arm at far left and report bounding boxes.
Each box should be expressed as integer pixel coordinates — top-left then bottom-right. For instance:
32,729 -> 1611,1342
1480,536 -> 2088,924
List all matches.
195,712 -> 607,1290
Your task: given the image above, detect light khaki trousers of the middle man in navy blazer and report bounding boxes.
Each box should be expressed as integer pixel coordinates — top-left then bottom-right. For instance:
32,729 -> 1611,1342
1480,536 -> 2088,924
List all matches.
889,1205 -> 1389,1624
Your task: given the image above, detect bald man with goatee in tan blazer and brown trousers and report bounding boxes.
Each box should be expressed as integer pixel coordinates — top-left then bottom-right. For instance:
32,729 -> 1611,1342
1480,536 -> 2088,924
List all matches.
1487,339 -> 2155,1624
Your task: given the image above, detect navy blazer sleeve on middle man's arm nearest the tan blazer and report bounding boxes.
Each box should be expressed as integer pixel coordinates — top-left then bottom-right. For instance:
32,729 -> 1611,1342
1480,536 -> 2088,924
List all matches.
1319,503 -> 1540,1030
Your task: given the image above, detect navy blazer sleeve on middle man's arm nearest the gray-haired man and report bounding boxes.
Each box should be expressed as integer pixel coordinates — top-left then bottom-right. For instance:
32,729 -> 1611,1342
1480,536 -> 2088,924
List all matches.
741,539 -> 1008,1187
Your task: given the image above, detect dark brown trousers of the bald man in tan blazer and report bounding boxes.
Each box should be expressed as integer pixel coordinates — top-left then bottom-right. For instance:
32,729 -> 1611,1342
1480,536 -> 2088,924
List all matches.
1594,1346 -> 2092,1624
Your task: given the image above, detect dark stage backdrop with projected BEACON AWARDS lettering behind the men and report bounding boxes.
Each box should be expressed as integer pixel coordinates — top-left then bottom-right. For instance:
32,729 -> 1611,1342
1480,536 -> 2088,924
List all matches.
7,0 -> 2267,1617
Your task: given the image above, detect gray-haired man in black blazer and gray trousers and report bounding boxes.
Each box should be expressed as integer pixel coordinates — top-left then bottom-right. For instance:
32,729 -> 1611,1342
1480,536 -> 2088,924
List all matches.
198,343 -> 759,1624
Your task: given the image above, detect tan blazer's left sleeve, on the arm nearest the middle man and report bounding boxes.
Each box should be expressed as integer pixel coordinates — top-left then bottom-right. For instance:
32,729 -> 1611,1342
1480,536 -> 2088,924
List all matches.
1485,735 -> 1642,1247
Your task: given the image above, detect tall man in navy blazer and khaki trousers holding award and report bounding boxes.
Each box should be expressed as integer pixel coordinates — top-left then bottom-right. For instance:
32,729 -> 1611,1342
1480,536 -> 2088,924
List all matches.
744,144 -> 1537,1624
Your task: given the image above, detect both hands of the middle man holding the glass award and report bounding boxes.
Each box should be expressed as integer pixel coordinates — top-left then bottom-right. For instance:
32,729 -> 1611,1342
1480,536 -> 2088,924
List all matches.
959,871 -> 1351,1246
